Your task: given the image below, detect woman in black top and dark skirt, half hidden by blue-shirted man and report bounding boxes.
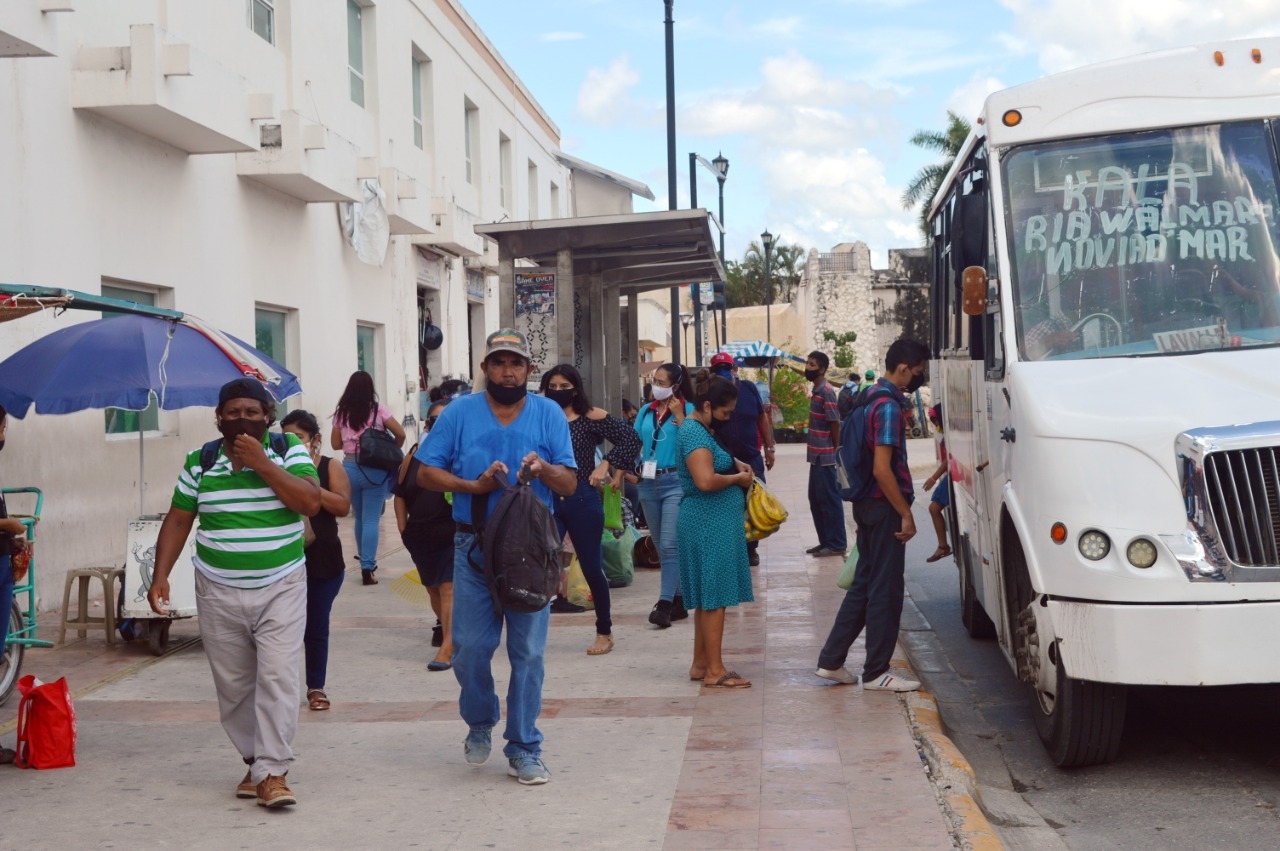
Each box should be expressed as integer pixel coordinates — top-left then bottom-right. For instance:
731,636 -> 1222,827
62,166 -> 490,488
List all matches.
396,399 -> 457,671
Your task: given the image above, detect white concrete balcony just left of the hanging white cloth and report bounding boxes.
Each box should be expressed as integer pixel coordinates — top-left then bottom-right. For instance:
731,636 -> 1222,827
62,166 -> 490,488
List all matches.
236,110 -> 363,203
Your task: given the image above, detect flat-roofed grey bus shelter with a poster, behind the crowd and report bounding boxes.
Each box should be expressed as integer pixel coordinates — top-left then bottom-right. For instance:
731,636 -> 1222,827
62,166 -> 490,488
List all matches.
475,210 -> 724,413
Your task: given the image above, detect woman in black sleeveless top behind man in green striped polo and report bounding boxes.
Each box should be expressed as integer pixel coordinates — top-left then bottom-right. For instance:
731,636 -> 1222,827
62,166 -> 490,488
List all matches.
280,410 -> 351,712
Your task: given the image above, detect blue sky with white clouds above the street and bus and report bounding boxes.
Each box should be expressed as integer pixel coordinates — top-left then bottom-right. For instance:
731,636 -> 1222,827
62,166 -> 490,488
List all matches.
461,0 -> 1280,266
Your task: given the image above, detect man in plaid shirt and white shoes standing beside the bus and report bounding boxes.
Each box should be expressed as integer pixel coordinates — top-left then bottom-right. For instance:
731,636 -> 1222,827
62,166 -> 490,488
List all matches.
817,338 -> 929,691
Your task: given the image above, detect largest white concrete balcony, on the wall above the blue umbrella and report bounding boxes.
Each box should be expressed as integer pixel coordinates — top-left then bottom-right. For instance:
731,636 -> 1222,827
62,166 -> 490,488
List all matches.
72,24 -> 263,154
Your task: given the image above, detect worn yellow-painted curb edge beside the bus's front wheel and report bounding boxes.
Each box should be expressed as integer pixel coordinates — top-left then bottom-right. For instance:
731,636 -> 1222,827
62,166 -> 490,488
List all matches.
893,645 -> 1005,851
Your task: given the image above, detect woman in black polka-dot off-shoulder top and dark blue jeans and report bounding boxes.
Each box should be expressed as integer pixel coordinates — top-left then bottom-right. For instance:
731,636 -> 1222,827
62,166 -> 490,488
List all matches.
543,363 -> 640,656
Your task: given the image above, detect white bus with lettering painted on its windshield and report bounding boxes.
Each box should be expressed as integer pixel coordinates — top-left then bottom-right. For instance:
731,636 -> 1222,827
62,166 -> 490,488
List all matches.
931,38 -> 1280,767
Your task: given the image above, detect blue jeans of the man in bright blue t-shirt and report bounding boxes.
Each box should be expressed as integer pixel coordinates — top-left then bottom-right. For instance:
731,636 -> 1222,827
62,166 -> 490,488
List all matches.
453,532 -> 550,759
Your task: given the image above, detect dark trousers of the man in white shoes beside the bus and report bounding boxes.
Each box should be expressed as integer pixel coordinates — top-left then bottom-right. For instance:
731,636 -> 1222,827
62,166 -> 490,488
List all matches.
818,499 -> 906,681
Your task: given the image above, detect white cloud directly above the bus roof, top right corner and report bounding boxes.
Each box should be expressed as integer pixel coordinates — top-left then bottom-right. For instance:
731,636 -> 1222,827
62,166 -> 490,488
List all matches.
1000,0 -> 1280,73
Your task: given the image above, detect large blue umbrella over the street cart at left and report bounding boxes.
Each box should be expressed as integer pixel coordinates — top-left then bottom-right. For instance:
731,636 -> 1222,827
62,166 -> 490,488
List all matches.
0,315 -> 302,418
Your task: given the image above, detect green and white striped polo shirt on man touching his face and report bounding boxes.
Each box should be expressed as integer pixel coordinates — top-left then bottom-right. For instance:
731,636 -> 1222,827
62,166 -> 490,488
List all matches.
173,434 -> 319,589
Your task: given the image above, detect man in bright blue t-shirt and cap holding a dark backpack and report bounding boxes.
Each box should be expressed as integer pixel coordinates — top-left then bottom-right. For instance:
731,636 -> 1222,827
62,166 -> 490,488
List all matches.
416,329 -> 577,786
